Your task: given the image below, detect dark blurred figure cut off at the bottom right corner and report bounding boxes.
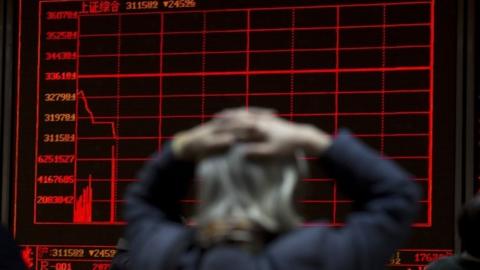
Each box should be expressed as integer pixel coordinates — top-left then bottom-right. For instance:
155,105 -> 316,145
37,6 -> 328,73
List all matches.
426,193 -> 480,270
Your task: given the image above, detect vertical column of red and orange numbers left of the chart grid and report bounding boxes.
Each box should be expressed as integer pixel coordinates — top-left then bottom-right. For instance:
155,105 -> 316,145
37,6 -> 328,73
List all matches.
34,2 -> 81,223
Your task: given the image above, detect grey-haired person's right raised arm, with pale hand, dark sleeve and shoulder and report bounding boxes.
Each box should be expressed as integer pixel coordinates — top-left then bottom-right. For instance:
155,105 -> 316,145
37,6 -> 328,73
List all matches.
242,118 -> 419,270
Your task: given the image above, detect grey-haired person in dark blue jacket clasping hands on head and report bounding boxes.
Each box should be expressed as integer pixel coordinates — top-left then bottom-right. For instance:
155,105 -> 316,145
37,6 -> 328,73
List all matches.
125,108 -> 419,270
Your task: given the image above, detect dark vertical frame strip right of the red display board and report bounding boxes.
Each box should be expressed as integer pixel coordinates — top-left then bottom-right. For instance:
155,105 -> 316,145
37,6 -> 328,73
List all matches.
455,0 -> 480,252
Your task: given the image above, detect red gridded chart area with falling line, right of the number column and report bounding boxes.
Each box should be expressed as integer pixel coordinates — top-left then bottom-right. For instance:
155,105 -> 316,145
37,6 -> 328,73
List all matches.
33,1 -> 434,226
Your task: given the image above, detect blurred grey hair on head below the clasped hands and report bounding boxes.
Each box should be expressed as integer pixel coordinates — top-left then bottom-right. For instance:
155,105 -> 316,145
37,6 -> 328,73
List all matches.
195,145 -> 307,233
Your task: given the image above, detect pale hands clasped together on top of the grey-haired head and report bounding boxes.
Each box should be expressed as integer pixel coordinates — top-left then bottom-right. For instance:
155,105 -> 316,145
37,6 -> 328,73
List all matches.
174,108 -> 330,160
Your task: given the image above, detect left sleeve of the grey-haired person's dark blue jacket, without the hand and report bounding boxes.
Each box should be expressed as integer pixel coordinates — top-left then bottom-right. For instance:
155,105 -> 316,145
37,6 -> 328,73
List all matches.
125,133 -> 195,270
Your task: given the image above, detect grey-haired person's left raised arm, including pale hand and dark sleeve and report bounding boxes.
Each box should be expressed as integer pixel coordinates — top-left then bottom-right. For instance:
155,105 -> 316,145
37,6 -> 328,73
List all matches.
125,108 -> 272,270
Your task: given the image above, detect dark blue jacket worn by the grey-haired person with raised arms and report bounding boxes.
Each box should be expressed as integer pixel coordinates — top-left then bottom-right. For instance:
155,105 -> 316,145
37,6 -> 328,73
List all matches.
125,132 -> 419,270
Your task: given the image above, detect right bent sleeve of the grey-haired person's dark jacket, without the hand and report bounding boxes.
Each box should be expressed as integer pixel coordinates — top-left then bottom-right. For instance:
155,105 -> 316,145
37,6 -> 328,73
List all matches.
322,132 -> 420,270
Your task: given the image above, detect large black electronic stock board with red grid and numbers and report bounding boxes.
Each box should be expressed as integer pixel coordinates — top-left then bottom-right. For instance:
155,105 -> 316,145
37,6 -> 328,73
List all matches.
13,0 -> 455,269
